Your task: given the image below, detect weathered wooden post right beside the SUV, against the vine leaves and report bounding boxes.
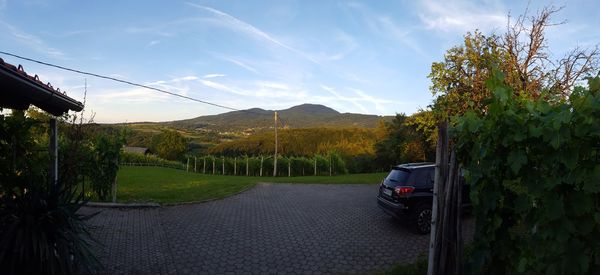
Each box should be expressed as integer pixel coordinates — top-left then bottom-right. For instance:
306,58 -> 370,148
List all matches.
427,122 -> 448,275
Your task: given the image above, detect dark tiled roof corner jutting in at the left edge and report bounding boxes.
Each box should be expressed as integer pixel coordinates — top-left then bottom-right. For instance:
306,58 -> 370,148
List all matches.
0,58 -> 83,116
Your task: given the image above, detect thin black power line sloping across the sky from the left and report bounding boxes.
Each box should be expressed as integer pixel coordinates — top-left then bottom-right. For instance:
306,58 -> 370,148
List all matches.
0,51 -> 272,115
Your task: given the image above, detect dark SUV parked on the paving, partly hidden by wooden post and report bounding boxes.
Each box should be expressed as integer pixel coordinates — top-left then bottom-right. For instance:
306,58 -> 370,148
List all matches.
377,162 -> 468,234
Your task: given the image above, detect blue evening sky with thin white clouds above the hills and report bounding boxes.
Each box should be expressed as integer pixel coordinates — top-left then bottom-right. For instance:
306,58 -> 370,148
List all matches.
0,0 -> 600,123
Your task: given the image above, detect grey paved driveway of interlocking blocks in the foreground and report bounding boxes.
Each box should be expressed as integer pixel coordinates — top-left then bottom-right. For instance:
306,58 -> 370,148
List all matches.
84,184 -> 472,274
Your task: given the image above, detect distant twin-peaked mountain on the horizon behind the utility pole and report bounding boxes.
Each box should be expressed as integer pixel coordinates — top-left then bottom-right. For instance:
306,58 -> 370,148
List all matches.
164,104 -> 393,132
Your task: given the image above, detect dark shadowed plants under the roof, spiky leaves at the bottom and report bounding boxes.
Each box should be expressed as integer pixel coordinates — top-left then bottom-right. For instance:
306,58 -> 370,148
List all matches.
0,111 -> 98,274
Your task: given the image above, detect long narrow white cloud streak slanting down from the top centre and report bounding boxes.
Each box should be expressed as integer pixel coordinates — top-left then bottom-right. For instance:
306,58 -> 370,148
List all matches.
187,3 -> 319,63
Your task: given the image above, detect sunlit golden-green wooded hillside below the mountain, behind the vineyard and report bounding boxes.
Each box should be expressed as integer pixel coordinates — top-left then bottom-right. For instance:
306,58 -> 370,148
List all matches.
119,112 -> 434,173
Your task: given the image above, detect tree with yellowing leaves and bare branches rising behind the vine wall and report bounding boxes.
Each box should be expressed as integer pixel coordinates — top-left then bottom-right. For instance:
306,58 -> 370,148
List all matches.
423,7 -> 600,123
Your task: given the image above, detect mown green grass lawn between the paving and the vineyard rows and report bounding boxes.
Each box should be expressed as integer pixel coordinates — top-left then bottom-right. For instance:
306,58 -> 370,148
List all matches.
117,166 -> 387,203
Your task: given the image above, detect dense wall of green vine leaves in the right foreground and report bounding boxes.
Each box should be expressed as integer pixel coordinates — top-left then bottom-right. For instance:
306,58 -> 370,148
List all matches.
452,72 -> 600,274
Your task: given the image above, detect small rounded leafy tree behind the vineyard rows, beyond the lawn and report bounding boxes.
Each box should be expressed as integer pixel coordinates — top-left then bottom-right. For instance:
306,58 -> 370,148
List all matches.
152,130 -> 187,160
